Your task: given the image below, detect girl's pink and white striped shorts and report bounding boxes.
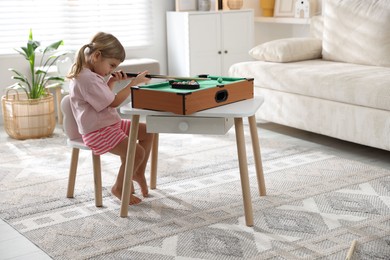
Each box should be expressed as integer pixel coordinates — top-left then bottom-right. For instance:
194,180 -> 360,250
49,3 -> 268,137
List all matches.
82,119 -> 131,155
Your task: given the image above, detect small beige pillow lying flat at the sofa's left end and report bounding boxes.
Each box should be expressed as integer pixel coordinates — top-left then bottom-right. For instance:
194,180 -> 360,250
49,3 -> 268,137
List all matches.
249,38 -> 321,62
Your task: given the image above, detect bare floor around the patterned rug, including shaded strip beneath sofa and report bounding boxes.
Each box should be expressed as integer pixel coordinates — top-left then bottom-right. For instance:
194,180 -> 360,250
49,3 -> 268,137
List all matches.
0,123 -> 390,260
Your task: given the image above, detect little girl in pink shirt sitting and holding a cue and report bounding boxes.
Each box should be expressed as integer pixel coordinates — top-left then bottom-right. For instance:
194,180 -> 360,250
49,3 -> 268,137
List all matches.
68,32 -> 153,204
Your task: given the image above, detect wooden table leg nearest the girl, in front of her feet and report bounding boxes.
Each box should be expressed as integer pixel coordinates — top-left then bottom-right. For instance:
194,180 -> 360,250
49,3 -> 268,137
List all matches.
120,115 -> 139,218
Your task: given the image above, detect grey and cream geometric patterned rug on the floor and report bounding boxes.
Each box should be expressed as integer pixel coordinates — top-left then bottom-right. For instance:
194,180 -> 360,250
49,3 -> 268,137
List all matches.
0,125 -> 390,260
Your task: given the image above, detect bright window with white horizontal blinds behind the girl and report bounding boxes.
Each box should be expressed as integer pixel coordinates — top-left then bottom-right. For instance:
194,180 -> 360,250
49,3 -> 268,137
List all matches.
0,0 -> 153,54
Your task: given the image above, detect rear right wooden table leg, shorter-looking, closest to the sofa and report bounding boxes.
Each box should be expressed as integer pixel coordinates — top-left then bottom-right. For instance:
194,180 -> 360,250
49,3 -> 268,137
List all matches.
248,115 -> 267,196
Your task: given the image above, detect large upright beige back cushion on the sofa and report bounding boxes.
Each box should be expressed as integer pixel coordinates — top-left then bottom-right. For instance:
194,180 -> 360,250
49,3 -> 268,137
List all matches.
322,0 -> 390,67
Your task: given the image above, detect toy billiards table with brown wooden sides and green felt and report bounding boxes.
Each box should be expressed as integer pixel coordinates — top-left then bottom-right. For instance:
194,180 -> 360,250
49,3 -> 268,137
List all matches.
131,75 -> 253,115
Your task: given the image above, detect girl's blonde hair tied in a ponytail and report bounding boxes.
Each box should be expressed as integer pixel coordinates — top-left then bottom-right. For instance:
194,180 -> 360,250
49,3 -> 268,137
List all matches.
67,32 -> 126,78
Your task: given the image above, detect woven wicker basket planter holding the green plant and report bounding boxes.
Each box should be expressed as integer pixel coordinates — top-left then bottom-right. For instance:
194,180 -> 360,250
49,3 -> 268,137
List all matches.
1,91 -> 56,140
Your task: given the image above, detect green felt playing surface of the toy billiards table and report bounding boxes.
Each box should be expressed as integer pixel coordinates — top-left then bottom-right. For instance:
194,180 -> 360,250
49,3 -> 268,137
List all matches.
141,76 -> 245,93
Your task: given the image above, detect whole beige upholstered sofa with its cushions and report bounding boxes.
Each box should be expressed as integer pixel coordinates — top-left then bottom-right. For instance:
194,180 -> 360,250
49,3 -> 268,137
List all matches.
229,0 -> 390,150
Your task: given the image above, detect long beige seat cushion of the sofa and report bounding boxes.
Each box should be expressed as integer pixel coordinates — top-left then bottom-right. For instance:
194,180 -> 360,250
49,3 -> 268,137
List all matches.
229,60 -> 390,111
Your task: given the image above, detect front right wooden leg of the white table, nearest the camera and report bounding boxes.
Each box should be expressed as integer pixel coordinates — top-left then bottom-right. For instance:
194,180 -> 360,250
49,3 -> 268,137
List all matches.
234,118 -> 253,227
